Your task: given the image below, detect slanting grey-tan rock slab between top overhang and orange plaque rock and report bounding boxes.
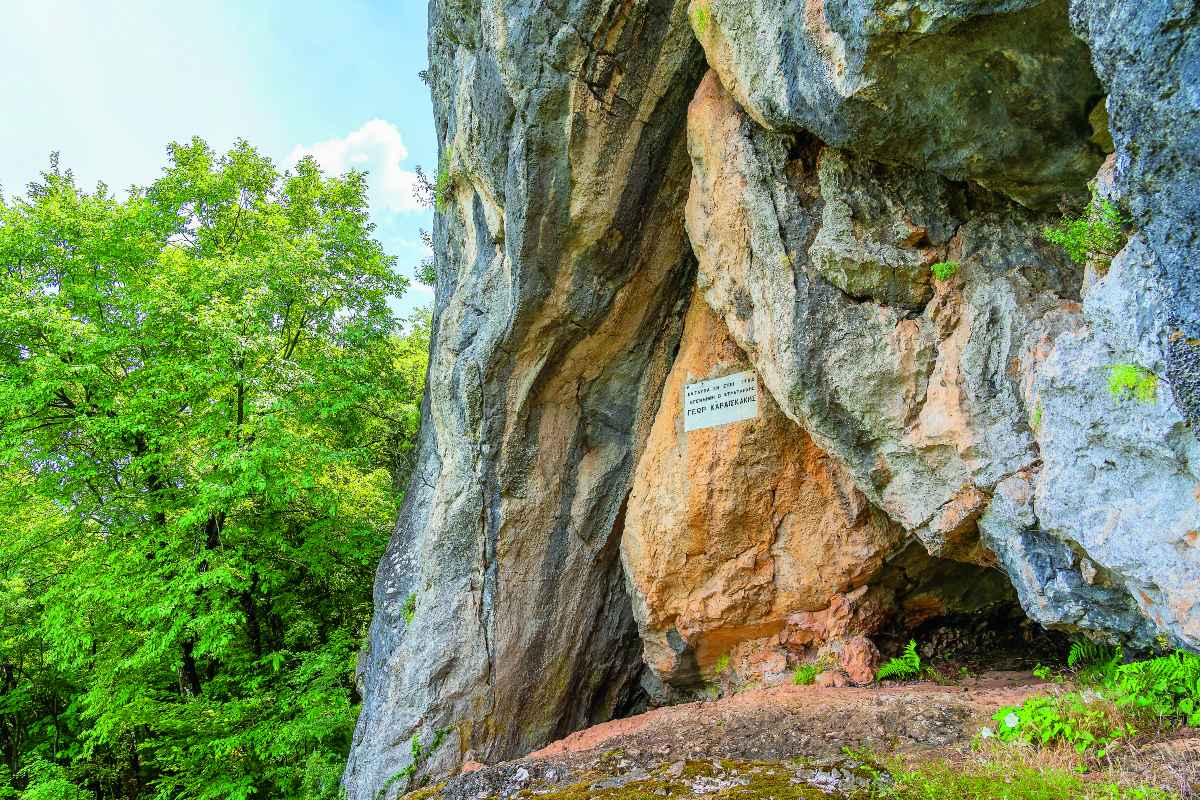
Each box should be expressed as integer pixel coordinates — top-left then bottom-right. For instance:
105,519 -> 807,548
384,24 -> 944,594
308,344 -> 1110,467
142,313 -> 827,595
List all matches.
686,73 -> 1080,544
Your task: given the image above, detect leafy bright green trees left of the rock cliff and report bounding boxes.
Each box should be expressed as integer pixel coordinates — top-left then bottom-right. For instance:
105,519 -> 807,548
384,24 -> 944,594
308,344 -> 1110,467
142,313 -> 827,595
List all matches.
0,139 -> 428,799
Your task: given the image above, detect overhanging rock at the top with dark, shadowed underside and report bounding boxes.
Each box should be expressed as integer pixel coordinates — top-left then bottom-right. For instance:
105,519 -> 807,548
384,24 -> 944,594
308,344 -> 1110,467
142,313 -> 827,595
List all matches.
691,0 -> 1099,205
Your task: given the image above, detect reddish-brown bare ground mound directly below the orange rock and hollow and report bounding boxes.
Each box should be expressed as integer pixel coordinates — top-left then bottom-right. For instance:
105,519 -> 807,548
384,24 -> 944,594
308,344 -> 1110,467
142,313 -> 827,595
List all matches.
414,672 -> 1052,800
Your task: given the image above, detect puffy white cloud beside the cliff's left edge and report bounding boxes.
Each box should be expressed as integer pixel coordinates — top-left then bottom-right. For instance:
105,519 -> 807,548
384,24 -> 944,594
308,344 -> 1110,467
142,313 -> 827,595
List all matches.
288,120 -> 425,211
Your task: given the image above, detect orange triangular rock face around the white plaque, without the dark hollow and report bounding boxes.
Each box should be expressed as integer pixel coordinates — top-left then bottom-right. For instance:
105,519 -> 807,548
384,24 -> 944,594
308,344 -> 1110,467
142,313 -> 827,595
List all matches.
622,295 -> 904,687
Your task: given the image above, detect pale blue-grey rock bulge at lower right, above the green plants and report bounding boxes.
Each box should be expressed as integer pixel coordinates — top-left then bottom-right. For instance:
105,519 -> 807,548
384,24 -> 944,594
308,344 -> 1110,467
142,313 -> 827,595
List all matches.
982,234 -> 1200,649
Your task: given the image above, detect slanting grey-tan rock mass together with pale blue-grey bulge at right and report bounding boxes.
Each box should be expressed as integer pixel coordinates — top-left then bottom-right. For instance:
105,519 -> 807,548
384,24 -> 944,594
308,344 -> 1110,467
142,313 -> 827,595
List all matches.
688,73 -> 1200,646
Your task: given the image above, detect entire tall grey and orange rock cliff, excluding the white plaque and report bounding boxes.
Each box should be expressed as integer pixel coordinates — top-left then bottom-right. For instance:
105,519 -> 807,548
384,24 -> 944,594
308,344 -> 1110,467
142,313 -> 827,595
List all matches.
344,0 -> 1200,800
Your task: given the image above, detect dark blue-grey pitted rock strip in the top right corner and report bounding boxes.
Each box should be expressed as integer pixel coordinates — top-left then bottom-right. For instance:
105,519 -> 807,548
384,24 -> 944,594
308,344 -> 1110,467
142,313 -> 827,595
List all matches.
1070,0 -> 1200,425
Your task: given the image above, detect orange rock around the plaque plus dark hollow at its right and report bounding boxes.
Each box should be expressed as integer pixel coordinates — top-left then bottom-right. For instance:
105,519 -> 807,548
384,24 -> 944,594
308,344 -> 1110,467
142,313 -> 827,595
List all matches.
622,293 -> 1015,698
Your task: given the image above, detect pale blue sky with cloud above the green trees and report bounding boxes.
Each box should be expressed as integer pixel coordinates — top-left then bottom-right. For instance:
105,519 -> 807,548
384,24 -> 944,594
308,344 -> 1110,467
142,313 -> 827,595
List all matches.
0,0 -> 437,313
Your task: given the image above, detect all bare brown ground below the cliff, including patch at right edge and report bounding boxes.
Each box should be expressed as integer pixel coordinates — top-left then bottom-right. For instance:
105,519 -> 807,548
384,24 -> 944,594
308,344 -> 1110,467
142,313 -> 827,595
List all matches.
409,672 -> 1200,800
